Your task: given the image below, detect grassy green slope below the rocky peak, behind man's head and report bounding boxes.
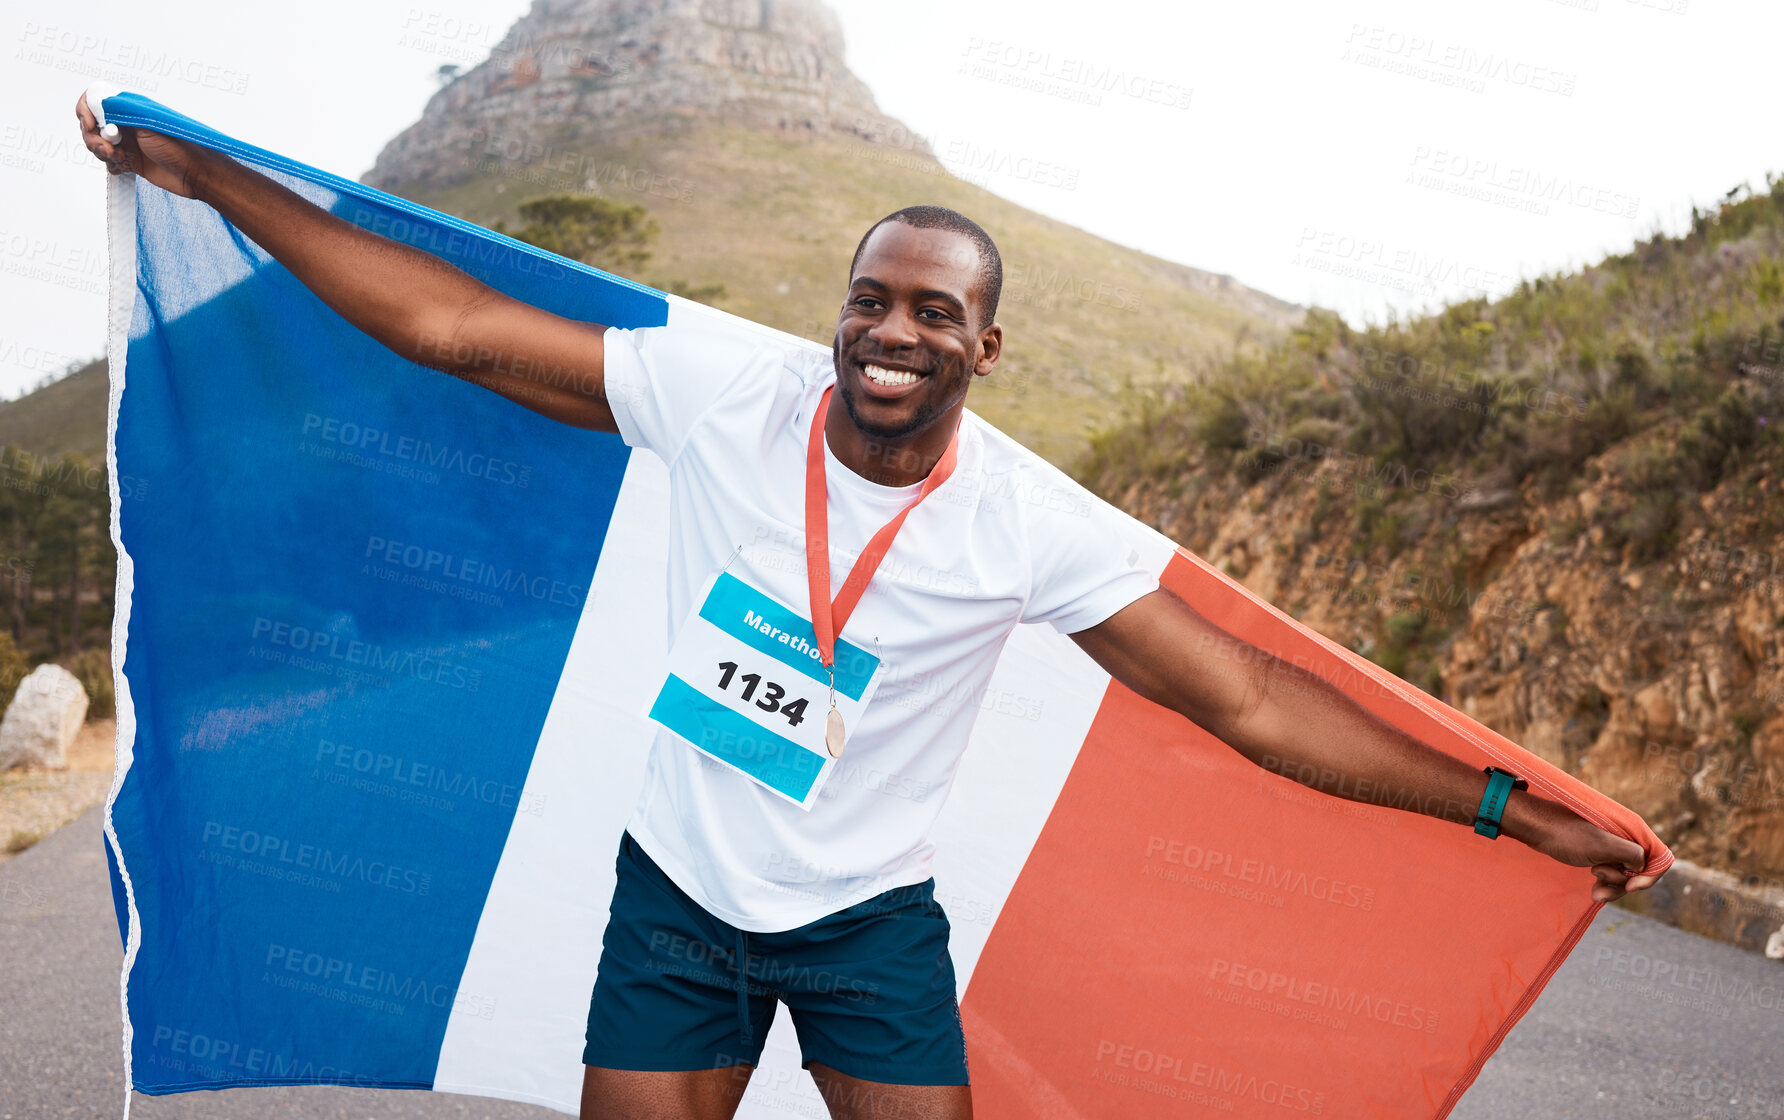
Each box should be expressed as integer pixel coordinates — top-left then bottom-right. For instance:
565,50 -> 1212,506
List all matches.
396,123 -> 1299,464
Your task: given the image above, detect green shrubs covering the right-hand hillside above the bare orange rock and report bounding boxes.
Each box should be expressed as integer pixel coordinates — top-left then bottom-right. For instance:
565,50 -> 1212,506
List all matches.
1074,178 -> 1784,731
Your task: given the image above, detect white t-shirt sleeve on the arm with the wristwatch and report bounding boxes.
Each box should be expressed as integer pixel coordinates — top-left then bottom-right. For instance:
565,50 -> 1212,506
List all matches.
1022,474 -> 1158,633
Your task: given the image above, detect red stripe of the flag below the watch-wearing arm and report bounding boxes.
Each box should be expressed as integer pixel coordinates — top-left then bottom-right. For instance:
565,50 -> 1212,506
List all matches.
962,553 -> 1672,1120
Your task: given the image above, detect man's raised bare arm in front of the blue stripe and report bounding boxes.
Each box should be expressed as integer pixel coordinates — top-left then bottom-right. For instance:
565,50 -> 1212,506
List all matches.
75,95 -> 617,432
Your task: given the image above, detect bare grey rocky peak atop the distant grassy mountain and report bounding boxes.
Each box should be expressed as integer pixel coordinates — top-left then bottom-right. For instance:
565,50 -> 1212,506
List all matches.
366,0 -> 928,189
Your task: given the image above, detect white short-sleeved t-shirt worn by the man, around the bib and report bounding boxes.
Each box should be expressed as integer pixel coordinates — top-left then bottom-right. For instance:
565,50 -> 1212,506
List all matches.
605,326 -> 1158,933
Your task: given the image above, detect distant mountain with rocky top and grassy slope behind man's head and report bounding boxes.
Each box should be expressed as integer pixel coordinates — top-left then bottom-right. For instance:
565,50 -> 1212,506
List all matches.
364,0 -> 1301,464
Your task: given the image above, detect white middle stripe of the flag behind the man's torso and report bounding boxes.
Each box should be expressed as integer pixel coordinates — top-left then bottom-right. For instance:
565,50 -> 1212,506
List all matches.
435,298 -> 1176,1120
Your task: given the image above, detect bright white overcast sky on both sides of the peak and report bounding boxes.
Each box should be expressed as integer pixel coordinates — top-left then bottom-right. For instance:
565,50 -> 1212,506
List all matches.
0,0 -> 1784,396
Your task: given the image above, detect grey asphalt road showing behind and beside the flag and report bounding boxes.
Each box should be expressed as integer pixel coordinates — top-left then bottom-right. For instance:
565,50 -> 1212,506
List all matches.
0,810 -> 1784,1120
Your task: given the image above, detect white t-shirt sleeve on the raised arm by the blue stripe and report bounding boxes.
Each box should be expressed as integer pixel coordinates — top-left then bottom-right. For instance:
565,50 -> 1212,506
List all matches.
601,326 -> 778,462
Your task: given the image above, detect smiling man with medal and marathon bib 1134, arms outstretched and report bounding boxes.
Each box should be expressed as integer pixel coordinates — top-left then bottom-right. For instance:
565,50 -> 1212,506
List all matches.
77,102 -> 1652,1120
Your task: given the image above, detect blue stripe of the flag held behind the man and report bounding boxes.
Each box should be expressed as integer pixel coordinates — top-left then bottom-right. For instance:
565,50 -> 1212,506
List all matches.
107,95 -> 667,1093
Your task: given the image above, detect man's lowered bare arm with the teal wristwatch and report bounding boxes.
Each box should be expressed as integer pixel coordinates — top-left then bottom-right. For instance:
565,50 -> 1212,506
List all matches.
1072,589 -> 1656,901
